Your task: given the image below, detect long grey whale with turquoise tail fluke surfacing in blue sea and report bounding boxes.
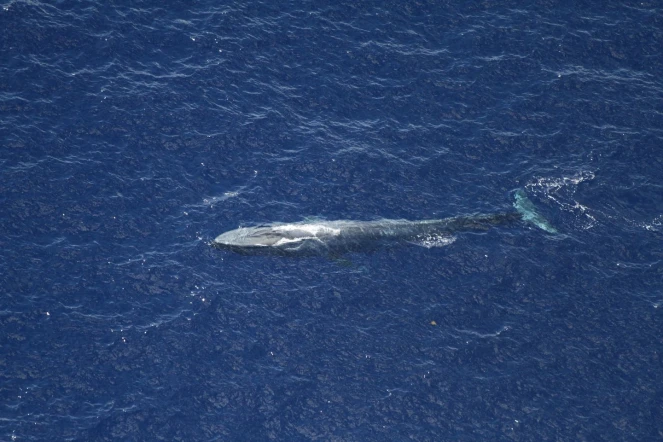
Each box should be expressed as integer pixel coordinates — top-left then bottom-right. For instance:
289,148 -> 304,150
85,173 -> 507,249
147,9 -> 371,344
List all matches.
211,189 -> 557,256
